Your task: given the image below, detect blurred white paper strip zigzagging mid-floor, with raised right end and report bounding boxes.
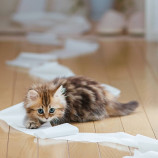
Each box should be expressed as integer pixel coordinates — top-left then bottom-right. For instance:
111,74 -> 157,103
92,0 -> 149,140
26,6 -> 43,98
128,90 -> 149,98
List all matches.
6,39 -> 99,68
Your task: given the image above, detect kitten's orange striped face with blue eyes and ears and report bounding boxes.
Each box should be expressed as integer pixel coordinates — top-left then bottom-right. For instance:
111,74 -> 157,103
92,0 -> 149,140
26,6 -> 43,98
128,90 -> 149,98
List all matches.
25,86 -> 66,122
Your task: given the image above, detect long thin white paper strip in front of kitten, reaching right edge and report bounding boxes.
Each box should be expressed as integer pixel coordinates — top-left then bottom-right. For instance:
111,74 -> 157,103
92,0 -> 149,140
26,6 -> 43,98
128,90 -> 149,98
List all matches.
55,132 -> 158,153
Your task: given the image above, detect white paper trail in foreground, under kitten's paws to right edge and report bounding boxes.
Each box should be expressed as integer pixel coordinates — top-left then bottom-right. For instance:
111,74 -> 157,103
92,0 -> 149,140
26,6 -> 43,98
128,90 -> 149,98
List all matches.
0,103 -> 158,158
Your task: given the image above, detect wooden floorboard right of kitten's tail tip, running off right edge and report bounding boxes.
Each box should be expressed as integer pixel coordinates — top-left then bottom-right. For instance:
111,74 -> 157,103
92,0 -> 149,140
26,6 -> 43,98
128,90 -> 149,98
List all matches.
129,43 -> 158,138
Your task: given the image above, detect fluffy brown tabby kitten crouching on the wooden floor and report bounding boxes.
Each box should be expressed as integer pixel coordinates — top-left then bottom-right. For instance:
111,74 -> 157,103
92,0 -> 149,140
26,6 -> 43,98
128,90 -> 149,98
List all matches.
24,77 -> 138,129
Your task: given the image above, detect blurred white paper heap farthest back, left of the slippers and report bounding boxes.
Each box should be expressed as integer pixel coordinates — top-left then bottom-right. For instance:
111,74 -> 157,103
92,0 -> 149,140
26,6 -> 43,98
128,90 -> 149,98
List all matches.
12,12 -> 91,36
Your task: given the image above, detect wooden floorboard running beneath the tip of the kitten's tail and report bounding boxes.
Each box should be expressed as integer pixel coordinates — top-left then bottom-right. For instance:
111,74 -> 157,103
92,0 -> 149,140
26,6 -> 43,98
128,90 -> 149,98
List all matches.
101,42 -> 154,137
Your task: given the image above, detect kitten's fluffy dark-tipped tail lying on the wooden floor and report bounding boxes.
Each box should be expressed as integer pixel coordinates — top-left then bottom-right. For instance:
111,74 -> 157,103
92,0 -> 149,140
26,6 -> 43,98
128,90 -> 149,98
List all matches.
106,101 -> 139,116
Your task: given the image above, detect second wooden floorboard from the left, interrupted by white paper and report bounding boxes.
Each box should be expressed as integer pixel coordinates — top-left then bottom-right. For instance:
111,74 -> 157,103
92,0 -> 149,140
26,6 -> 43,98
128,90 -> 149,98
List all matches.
8,42 -> 38,158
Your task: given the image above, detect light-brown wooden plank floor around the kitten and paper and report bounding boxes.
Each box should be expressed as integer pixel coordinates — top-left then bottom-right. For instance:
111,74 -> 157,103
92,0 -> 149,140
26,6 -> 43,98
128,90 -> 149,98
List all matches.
0,39 -> 158,158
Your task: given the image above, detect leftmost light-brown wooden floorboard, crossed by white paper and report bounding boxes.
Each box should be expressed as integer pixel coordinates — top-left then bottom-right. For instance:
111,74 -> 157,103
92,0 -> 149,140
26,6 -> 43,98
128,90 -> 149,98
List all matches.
0,42 -> 17,158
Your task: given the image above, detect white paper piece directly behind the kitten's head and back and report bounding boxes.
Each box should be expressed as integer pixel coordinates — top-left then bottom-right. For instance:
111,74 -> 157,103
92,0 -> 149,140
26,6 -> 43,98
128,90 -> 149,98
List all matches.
29,62 -> 75,81
